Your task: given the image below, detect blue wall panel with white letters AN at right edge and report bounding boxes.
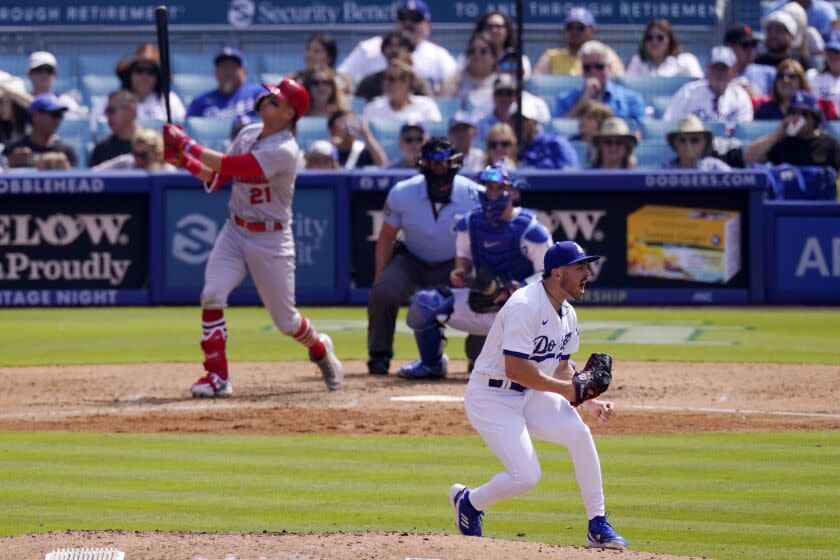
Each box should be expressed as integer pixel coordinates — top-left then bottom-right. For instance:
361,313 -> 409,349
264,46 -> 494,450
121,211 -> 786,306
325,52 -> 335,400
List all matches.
768,203 -> 840,304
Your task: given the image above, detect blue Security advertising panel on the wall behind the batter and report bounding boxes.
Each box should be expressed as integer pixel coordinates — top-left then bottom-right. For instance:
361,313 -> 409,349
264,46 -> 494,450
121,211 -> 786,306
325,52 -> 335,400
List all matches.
159,183 -> 343,304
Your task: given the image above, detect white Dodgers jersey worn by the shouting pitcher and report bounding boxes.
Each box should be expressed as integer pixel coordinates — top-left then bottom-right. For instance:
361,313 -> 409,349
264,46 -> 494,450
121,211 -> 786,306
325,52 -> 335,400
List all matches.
473,282 -> 580,379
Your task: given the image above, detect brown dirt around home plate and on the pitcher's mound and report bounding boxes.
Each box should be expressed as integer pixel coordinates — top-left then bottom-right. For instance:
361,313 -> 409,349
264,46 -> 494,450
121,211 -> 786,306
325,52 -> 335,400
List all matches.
0,362 -> 840,560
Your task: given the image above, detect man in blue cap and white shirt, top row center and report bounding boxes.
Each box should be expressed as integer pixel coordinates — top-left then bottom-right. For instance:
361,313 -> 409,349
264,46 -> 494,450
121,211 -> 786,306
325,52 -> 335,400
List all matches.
338,0 -> 458,90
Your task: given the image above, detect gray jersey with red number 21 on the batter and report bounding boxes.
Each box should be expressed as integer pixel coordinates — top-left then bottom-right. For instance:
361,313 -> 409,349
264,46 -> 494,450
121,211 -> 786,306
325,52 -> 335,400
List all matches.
228,123 -> 299,224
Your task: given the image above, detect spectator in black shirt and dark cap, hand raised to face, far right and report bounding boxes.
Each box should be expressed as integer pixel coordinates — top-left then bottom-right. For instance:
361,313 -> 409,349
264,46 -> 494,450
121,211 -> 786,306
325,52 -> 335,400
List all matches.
744,90 -> 840,169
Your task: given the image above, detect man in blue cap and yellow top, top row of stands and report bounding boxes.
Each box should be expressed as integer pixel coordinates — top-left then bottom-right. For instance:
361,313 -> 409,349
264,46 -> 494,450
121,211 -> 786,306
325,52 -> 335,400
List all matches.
534,6 -> 624,78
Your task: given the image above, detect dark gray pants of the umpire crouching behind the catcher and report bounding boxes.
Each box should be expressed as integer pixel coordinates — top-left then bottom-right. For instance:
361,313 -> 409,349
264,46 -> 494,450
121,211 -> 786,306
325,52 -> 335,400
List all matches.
368,249 -> 455,359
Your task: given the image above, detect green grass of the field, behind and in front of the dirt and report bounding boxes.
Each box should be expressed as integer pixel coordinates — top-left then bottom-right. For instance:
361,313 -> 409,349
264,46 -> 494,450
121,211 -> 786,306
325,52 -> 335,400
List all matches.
0,308 -> 840,560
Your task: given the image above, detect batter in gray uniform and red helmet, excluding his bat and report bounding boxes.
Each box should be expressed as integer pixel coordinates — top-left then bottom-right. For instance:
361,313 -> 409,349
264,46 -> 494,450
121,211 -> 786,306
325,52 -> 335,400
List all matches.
163,79 -> 344,397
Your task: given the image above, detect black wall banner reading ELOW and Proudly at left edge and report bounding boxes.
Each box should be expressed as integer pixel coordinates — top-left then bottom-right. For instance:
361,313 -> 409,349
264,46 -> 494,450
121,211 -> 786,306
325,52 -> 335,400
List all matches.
0,192 -> 149,306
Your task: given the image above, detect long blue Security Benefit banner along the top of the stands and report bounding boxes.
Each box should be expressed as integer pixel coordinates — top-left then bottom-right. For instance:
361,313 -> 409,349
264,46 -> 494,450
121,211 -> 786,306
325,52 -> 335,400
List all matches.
0,0 -> 720,30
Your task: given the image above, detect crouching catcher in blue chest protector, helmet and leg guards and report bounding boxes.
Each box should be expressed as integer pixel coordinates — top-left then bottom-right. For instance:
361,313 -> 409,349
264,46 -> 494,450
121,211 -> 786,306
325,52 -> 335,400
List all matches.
398,162 -> 551,379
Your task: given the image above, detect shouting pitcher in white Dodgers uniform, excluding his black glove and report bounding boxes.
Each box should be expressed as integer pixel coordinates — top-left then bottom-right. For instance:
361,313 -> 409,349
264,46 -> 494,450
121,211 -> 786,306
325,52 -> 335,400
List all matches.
449,241 -> 627,550
